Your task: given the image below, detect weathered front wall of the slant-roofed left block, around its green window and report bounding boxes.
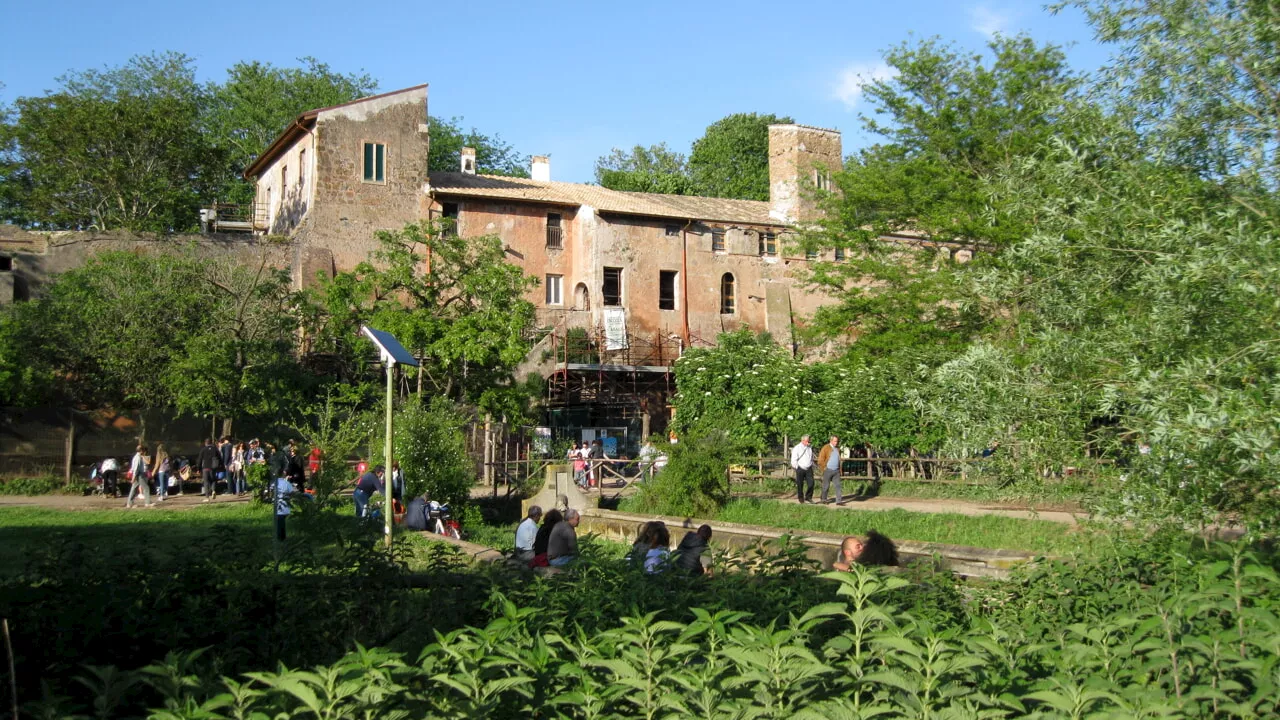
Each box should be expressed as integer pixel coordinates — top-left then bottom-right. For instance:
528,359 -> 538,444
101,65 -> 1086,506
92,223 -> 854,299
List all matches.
302,88 -> 429,270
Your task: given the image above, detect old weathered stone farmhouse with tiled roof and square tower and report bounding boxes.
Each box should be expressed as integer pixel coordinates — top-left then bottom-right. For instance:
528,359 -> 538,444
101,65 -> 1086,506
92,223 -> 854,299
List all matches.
244,85 -> 842,346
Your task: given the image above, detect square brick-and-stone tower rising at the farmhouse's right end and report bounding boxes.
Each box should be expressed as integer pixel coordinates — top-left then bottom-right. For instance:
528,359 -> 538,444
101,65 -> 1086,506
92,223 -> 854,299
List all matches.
769,124 -> 844,223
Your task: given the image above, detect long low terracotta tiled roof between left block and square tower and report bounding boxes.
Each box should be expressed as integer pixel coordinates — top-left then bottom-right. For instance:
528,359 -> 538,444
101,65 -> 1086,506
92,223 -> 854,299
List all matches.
430,173 -> 783,225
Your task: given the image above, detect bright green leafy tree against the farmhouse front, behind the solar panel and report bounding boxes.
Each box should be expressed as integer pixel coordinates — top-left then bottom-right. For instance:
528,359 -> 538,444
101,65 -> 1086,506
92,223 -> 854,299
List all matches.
315,222 -> 538,410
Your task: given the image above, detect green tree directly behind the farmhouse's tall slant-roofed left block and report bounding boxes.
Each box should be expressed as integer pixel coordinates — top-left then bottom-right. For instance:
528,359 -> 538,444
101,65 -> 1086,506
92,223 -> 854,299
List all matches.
205,56 -> 376,202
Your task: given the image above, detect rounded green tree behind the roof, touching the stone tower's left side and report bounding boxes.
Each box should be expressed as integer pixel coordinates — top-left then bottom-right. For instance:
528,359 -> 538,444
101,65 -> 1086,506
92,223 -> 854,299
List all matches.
689,113 -> 792,200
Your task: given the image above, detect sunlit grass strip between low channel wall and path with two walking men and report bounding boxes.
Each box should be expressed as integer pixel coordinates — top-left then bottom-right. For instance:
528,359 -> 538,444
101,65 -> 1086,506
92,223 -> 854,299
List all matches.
620,498 -> 1102,556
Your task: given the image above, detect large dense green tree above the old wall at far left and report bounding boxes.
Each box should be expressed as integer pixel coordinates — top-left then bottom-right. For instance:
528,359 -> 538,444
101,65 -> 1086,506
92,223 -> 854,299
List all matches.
5,53 -> 218,232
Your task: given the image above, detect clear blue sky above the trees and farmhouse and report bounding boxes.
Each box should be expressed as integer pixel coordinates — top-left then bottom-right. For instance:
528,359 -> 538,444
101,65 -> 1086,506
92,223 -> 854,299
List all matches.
0,0 -> 1107,182
